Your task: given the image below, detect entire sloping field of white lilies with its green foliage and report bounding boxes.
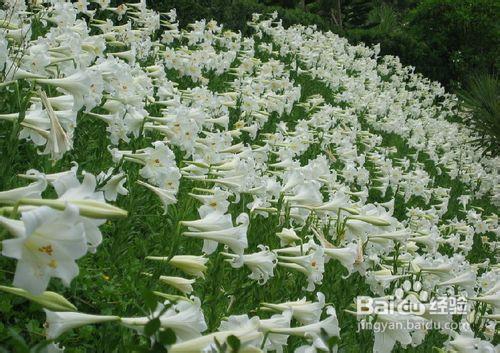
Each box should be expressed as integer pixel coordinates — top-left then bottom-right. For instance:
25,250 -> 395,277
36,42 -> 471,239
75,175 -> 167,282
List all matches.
0,0 -> 500,353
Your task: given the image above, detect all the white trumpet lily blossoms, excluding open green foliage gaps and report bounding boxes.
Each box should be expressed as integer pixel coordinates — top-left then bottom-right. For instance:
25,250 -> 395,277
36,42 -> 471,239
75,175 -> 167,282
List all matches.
0,0 -> 500,353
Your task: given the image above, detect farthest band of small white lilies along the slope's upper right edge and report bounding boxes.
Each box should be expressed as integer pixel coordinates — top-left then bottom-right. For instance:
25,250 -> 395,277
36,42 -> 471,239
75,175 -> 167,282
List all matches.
255,18 -> 500,206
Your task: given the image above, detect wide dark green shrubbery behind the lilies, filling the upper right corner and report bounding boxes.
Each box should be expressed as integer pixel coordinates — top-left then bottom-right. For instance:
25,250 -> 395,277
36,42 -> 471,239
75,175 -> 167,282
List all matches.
344,0 -> 500,88
